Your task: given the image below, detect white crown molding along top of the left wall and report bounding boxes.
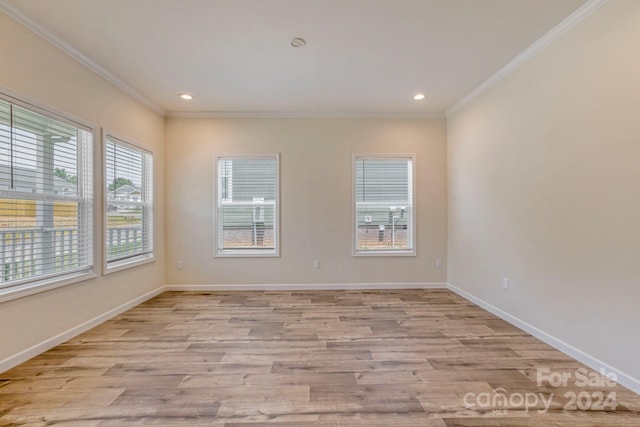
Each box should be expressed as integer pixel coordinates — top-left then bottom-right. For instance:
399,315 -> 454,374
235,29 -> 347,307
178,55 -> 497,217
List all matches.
0,0 -> 166,115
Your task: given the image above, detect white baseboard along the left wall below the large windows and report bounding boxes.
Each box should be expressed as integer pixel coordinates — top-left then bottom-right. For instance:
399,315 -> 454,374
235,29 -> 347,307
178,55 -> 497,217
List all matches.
0,286 -> 165,373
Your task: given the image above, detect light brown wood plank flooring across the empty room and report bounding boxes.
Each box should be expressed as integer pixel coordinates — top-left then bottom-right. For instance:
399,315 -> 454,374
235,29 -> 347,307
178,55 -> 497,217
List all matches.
0,290 -> 640,427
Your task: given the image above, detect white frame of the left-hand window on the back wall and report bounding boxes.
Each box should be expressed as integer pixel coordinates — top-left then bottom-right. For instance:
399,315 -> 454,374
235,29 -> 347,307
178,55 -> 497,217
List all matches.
213,153 -> 280,258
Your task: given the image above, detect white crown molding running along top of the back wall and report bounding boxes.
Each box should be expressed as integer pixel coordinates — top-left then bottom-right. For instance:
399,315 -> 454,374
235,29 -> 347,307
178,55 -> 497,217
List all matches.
167,111 -> 445,119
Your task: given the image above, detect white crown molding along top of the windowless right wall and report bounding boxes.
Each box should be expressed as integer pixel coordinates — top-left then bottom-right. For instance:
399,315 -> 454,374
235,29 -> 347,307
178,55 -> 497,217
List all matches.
445,0 -> 608,117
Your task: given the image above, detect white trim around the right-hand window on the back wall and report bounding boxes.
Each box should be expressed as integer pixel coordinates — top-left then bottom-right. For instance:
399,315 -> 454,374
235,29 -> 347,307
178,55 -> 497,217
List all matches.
351,153 -> 418,257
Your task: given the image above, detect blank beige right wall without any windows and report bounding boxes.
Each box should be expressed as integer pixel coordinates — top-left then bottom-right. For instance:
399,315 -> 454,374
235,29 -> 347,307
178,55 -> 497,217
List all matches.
447,0 -> 640,378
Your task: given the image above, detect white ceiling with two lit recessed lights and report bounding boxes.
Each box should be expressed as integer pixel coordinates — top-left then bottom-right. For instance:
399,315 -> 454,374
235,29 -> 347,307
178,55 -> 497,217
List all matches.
3,0 -> 585,115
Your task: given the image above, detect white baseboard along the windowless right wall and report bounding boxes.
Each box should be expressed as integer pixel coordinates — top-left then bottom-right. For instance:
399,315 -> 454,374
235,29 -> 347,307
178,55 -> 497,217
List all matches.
447,283 -> 640,394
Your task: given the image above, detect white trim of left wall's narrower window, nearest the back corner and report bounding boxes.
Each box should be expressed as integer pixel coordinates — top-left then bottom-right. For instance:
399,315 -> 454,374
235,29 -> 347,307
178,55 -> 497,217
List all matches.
100,129 -> 156,275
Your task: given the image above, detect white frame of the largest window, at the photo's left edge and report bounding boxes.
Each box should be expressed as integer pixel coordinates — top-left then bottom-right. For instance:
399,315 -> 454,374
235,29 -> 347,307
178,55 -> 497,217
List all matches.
0,86 -> 99,303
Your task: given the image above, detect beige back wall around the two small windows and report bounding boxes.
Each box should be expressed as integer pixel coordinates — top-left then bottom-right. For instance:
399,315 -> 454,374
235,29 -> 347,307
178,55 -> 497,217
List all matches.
167,118 -> 446,285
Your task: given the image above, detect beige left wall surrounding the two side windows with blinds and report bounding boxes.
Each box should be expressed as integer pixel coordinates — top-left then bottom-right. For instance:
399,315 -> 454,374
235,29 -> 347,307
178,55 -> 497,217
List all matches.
0,13 -> 165,361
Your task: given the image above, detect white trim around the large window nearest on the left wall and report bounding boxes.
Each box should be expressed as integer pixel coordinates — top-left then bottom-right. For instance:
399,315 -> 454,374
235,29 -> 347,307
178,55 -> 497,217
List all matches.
0,86 -> 99,303
